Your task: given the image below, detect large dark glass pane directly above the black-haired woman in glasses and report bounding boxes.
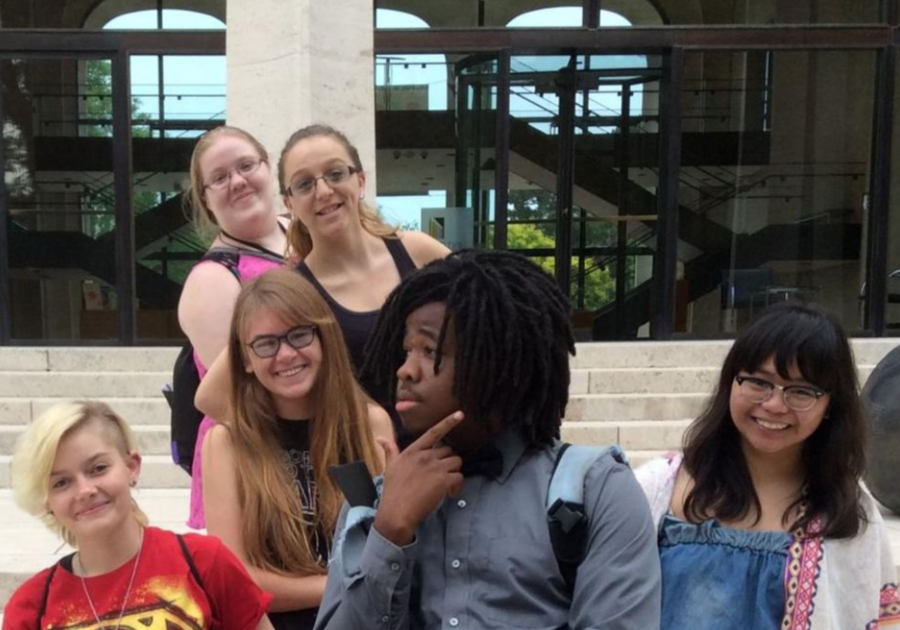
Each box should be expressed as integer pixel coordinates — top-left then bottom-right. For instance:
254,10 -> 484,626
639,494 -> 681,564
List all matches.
678,51 -> 875,335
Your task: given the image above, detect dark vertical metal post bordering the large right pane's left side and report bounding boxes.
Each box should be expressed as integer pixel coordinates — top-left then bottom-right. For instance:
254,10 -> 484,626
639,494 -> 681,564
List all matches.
650,48 -> 684,339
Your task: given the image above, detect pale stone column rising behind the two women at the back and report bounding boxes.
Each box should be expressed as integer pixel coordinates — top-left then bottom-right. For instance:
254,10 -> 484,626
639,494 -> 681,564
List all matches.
226,0 -> 376,191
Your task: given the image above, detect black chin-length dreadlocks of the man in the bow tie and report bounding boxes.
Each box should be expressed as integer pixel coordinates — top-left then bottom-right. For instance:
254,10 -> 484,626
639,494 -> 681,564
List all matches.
360,250 -> 575,447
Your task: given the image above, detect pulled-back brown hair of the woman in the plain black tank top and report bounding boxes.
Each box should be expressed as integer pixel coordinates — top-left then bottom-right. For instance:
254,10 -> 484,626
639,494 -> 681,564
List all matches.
278,125 -> 397,258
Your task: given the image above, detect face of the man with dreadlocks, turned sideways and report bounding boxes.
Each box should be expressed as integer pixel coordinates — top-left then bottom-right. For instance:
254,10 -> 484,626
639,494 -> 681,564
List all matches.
396,302 -> 460,435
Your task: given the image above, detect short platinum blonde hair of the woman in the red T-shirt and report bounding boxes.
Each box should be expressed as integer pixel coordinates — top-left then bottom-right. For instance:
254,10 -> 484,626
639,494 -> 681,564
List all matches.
11,400 -> 148,547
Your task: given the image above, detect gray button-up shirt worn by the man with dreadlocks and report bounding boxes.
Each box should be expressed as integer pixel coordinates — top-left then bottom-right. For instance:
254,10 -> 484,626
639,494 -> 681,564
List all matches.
316,432 -> 660,630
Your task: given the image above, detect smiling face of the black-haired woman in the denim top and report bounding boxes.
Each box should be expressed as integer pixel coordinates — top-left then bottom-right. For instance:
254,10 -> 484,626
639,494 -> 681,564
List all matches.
729,357 -> 830,458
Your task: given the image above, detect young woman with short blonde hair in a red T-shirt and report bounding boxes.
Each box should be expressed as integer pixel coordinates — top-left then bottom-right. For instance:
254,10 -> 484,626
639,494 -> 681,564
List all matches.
3,401 -> 272,630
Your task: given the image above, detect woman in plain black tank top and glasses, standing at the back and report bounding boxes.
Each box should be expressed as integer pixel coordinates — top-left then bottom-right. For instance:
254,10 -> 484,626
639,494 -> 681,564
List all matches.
278,125 -> 450,428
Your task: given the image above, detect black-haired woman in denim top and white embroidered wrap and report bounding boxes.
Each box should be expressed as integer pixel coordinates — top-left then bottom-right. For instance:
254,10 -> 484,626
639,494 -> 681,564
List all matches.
636,303 -> 900,630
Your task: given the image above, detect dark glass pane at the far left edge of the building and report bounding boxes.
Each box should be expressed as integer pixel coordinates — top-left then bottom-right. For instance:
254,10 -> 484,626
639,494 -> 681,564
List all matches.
0,58 -> 118,341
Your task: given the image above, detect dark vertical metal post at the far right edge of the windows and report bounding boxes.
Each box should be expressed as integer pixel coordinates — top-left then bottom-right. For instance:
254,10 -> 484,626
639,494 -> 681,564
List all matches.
864,46 -> 897,337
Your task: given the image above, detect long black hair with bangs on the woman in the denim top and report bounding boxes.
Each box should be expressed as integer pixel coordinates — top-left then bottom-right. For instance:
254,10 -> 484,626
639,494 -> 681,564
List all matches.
684,302 -> 866,538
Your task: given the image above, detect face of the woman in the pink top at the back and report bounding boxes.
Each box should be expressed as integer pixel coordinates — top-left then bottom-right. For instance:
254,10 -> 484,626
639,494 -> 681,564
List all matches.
199,134 -> 275,238
